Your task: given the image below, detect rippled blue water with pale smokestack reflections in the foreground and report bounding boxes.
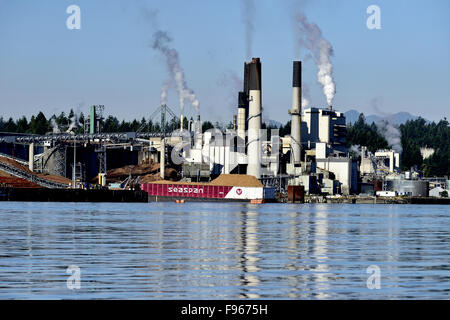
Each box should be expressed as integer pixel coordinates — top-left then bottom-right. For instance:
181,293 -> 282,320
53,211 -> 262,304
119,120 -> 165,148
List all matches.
0,202 -> 450,299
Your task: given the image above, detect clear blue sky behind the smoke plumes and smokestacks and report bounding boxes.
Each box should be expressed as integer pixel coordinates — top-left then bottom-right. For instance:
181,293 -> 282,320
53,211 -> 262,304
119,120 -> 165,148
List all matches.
0,0 -> 450,122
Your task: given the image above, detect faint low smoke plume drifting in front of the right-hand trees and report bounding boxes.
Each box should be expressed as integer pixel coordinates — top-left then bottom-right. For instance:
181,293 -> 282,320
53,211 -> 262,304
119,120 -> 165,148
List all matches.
370,98 -> 403,153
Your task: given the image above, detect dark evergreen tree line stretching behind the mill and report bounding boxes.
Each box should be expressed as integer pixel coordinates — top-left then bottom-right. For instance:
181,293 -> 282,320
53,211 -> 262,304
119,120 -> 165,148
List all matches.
0,109 -> 450,176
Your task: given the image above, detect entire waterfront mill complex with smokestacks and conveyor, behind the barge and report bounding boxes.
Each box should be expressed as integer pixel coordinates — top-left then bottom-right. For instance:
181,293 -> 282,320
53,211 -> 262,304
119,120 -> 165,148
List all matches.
0,58 -> 436,199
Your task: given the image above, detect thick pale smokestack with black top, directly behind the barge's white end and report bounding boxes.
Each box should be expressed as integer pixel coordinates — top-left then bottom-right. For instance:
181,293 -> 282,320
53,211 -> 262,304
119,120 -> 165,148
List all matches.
247,58 -> 262,179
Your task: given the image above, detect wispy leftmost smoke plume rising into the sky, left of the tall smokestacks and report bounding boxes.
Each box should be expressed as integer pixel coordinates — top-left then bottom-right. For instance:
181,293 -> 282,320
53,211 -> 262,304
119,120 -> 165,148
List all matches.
152,30 -> 200,113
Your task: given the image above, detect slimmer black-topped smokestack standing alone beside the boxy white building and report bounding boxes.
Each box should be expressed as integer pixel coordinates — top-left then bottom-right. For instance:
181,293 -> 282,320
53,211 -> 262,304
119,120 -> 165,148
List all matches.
289,61 -> 302,166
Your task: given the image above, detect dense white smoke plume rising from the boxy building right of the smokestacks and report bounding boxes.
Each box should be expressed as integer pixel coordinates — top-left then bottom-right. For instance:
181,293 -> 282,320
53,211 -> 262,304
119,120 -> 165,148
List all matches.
296,13 -> 336,106
